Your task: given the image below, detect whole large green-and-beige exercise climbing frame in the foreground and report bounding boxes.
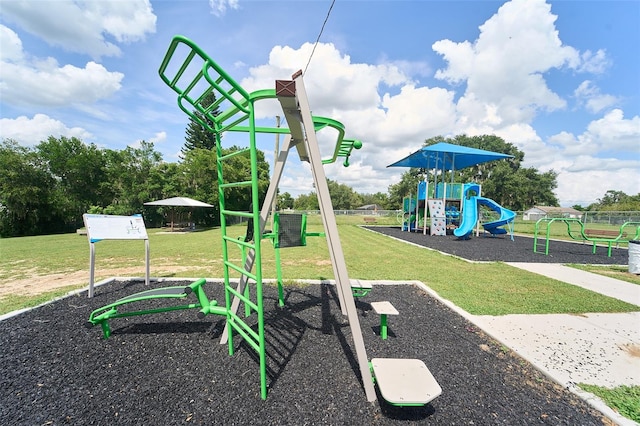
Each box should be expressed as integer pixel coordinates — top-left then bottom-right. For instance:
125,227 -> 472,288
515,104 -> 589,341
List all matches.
90,36 -> 442,406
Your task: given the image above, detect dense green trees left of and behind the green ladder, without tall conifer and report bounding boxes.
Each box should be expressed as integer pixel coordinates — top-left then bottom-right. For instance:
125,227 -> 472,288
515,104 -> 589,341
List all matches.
0,136 -> 269,237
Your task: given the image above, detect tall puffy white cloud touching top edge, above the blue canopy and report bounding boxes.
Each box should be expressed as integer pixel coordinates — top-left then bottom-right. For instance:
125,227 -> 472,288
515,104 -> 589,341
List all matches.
432,0 -> 579,127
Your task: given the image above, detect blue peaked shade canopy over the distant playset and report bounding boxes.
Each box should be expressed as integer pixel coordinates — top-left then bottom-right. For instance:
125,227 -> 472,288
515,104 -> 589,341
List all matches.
387,142 -> 513,170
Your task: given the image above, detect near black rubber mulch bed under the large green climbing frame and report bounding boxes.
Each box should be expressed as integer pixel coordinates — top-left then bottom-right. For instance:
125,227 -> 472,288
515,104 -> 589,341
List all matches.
0,278 -> 607,425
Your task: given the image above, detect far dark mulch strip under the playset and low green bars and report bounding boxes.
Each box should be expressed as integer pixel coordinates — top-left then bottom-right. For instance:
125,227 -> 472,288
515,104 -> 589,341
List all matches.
365,226 -> 629,265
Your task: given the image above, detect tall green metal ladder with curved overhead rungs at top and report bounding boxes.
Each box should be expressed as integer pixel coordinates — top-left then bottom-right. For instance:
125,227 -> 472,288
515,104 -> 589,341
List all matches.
159,36 -> 284,399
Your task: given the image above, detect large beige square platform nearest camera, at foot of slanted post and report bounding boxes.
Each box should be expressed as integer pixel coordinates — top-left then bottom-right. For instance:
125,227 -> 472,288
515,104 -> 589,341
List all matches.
371,358 -> 442,406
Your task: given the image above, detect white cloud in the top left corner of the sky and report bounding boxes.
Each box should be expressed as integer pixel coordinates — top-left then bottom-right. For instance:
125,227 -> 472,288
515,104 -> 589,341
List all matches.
2,0 -> 156,59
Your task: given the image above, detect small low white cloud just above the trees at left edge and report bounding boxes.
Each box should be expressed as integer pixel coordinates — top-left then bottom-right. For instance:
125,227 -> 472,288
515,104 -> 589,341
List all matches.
0,114 -> 93,145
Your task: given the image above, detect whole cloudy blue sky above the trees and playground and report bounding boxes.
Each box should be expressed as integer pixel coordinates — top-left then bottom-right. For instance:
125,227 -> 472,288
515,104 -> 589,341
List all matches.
0,0 -> 640,206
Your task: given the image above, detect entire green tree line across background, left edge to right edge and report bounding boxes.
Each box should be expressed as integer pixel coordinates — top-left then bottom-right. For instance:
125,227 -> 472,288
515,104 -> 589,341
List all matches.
0,133 -> 640,237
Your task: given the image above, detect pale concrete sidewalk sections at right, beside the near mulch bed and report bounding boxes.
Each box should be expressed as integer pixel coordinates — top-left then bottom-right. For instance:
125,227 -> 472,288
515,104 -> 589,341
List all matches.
470,263 -> 640,424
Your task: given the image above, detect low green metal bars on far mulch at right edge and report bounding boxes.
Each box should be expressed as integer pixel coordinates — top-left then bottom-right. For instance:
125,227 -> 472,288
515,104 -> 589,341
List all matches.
533,217 -> 640,257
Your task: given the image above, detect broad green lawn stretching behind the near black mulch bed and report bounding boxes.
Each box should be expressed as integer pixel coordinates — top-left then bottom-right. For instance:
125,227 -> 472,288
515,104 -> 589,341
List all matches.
0,215 -> 638,315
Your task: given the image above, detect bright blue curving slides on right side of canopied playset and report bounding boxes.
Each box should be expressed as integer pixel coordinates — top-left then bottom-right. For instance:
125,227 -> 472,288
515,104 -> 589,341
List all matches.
453,184 -> 516,240
